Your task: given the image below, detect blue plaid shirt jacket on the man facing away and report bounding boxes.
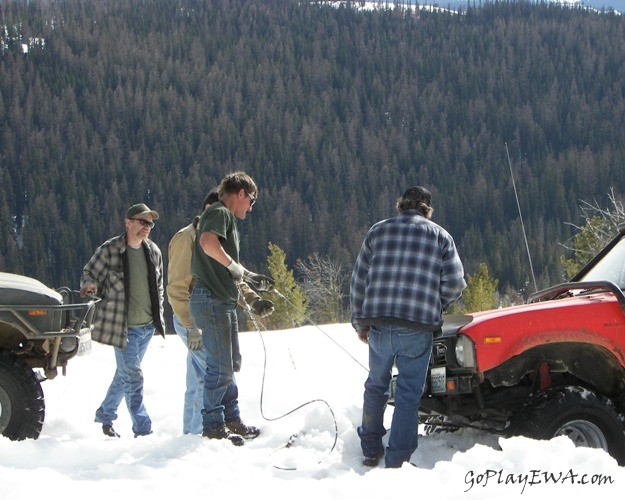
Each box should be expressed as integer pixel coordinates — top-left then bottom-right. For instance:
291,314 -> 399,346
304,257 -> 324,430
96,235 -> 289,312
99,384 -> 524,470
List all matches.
350,210 -> 467,331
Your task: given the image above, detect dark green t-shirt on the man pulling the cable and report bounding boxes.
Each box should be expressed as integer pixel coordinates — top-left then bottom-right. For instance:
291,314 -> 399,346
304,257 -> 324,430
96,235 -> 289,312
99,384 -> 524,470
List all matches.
191,202 -> 239,302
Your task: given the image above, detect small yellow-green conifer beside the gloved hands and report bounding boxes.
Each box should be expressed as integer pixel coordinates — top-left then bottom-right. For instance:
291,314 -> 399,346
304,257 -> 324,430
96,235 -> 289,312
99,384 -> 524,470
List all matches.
262,243 -> 307,330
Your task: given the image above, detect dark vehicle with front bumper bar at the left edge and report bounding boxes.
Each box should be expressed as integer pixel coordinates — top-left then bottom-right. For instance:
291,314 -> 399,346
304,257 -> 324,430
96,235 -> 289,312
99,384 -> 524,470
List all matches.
0,273 -> 99,440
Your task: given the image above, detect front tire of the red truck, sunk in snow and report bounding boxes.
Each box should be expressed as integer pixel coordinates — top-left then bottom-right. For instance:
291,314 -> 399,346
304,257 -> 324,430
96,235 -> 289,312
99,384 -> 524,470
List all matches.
507,386 -> 625,465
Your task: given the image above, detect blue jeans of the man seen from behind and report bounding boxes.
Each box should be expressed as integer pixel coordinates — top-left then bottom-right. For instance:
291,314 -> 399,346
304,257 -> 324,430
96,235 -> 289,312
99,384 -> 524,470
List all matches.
358,326 -> 432,468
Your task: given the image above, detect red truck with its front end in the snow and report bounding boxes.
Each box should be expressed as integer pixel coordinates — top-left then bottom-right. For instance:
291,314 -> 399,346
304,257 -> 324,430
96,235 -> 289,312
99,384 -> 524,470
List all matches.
412,228 -> 625,465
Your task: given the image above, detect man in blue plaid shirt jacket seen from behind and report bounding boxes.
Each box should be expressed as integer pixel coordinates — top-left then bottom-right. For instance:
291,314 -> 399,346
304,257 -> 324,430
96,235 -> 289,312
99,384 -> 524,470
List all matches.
350,186 -> 466,468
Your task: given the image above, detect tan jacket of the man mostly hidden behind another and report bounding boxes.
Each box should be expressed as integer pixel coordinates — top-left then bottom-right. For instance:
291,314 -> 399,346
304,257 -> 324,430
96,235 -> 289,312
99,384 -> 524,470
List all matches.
167,217 -> 259,327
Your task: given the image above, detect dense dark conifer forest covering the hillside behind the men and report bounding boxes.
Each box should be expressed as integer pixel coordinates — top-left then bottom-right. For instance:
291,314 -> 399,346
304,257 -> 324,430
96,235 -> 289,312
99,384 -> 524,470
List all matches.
0,0 -> 625,316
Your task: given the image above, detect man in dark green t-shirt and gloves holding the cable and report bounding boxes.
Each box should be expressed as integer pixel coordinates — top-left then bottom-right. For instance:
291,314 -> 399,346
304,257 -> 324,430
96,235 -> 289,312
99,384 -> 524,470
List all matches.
189,172 -> 273,446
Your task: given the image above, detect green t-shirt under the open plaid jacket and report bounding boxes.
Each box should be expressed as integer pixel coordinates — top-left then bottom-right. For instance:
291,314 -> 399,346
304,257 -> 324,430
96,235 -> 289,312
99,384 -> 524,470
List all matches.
126,245 -> 152,327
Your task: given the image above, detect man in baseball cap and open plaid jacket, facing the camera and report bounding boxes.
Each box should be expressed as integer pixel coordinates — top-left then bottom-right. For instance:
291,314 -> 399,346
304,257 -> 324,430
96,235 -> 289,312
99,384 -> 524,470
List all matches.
80,203 -> 165,438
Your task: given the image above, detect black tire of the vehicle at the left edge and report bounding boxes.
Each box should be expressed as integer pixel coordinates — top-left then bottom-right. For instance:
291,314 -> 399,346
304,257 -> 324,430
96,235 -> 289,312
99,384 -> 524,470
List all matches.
0,350 -> 45,441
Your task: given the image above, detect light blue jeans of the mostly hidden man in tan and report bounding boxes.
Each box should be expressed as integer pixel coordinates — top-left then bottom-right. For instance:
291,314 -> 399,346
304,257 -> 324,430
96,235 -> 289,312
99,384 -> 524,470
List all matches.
174,314 -> 206,434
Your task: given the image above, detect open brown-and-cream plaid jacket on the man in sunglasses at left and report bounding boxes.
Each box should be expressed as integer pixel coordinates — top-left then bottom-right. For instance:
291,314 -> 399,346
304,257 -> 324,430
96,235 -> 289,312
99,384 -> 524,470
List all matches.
80,233 -> 165,349
